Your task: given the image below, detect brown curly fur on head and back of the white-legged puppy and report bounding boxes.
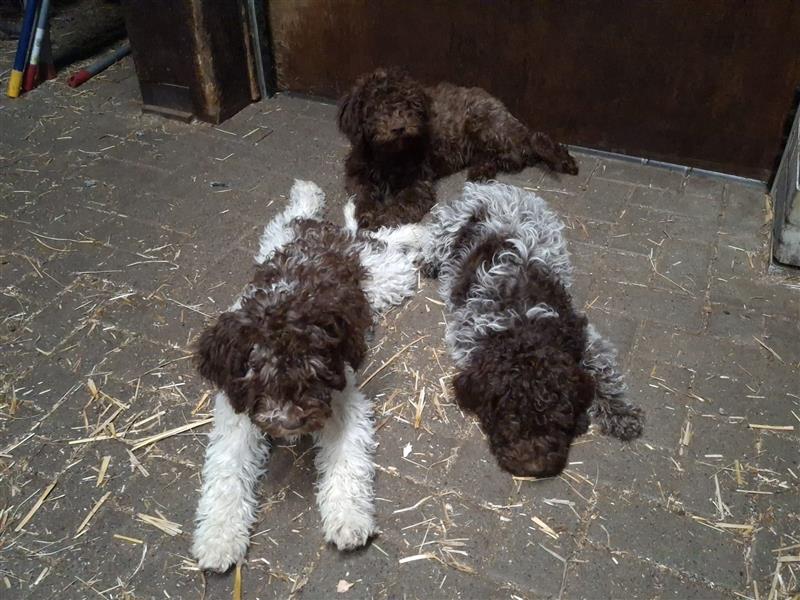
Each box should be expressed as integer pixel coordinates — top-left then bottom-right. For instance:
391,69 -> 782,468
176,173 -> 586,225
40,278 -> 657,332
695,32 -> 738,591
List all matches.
196,220 -> 372,436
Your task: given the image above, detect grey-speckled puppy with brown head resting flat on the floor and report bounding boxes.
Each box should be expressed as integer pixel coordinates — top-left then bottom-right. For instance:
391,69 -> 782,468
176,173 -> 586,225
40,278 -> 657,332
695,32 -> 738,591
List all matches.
423,183 -> 644,477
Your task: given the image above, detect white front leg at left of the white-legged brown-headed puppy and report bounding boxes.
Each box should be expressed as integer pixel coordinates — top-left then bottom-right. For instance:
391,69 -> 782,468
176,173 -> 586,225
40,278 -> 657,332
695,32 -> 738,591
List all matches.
192,392 -> 269,572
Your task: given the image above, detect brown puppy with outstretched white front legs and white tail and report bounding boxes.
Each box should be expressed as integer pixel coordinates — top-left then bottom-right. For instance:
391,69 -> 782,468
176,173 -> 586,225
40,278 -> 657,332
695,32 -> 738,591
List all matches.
192,181 -> 422,571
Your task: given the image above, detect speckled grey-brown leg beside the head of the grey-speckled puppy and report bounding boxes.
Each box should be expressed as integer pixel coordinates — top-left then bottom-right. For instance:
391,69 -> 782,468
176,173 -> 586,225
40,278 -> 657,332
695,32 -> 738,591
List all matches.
583,325 -> 645,441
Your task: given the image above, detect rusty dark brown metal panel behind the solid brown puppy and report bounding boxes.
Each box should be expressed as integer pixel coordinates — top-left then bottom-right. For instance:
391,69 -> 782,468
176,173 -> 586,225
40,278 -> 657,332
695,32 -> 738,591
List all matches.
267,0 -> 800,179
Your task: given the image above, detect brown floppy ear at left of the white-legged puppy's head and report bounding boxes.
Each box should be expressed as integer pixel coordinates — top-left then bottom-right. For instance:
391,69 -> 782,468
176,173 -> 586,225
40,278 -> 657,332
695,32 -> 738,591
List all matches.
194,312 -> 256,412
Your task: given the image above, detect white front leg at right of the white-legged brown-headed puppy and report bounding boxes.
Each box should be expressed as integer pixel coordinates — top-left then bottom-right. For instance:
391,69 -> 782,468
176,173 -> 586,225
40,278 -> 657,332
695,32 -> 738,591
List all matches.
315,367 -> 376,550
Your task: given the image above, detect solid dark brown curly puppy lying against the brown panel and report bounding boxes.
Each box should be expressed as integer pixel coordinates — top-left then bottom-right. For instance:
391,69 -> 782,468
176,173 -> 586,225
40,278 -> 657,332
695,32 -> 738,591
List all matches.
338,69 -> 578,229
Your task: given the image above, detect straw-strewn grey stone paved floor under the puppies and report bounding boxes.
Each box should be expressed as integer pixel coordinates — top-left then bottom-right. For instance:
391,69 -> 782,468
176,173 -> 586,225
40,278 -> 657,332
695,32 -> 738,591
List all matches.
0,54 -> 800,599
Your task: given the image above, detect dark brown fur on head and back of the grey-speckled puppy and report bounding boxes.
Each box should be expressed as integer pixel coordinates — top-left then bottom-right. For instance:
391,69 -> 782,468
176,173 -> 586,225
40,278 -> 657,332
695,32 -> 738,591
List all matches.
451,258 -> 595,477
